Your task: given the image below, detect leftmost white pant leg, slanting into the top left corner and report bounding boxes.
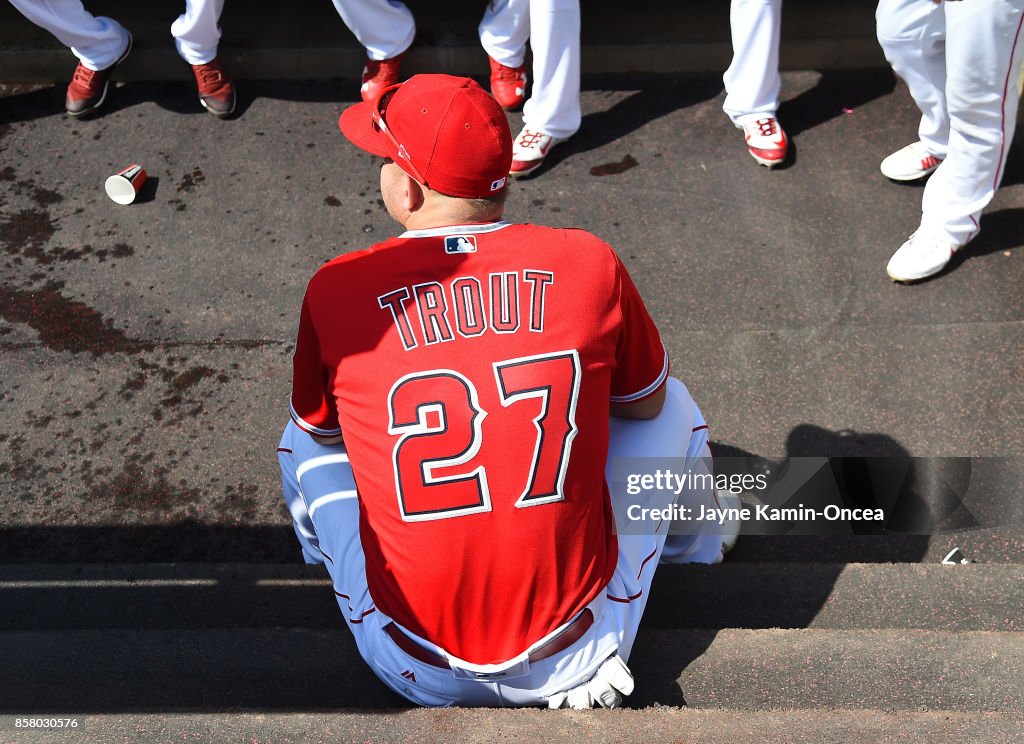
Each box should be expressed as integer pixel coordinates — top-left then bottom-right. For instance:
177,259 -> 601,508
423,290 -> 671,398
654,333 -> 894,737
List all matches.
10,0 -> 128,71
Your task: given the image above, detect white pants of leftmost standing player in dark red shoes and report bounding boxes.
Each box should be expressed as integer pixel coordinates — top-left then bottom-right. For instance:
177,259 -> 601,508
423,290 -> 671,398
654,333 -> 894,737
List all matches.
10,0 -> 224,71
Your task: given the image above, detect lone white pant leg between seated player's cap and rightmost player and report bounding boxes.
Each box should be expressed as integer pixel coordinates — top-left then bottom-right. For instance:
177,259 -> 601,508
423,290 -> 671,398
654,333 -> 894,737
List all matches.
722,0 -> 782,127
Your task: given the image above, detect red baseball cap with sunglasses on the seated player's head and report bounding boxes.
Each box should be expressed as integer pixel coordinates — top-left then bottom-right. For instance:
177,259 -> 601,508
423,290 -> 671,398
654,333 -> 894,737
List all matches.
338,75 -> 512,199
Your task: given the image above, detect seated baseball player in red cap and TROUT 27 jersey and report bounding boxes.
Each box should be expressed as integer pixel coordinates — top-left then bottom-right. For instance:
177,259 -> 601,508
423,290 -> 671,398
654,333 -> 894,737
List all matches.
279,75 -> 737,708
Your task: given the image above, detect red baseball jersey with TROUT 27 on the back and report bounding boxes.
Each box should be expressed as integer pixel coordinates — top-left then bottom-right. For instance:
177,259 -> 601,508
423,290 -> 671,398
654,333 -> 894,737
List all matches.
291,222 -> 669,664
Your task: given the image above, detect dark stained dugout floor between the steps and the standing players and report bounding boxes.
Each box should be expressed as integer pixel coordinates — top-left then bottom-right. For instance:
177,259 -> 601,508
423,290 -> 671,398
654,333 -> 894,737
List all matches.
0,70 -> 1024,560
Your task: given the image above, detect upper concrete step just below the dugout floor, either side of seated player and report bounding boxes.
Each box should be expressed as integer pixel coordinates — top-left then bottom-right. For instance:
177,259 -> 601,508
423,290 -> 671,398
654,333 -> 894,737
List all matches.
0,562 -> 1024,632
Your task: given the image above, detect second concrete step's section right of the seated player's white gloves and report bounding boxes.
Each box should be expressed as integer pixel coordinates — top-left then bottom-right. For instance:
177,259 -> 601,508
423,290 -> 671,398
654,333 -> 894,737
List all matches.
631,629 -> 1024,711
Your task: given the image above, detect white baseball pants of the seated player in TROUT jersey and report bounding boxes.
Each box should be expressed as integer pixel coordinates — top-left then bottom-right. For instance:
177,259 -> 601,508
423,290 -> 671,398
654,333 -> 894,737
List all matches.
278,378 -> 722,706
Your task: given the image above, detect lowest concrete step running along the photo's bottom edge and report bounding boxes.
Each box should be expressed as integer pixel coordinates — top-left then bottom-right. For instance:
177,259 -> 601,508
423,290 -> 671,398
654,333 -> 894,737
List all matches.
0,707 -> 1021,744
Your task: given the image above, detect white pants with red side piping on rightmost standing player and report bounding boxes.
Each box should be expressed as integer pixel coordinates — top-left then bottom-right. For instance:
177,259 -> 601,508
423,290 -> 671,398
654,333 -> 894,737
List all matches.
876,0 -> 1024,246
